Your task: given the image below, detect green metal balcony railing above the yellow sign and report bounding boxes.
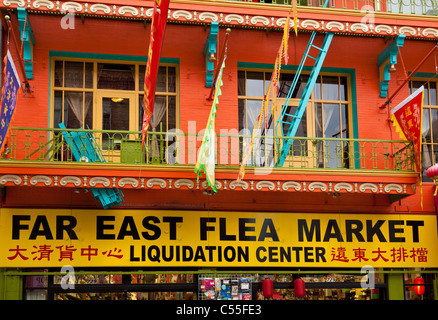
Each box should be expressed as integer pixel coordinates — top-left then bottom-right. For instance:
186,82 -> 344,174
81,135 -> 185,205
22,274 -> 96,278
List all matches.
0,128 -> 414,172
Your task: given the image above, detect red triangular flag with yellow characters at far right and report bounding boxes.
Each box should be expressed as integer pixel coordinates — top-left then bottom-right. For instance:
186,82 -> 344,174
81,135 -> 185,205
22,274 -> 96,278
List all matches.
391,86 -> 424,172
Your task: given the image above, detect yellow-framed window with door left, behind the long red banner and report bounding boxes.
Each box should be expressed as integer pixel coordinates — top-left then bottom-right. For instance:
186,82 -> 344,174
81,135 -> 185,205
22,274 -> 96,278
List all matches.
51,58 -> 178,163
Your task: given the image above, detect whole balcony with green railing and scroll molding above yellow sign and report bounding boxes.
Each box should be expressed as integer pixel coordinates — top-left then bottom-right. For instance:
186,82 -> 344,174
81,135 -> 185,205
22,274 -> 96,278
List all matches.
0,128 -> 417,201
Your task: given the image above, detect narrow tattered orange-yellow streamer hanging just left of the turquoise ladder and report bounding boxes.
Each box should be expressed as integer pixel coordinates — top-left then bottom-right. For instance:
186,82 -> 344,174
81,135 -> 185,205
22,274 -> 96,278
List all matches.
237,11 -> 292,182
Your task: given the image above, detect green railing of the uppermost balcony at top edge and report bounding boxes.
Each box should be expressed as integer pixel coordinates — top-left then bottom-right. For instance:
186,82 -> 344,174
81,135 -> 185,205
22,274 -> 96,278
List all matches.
234,0 -> 438,16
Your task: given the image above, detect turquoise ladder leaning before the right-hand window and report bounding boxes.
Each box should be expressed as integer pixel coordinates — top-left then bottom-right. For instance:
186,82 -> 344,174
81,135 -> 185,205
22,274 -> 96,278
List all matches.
275,0 -> 334,167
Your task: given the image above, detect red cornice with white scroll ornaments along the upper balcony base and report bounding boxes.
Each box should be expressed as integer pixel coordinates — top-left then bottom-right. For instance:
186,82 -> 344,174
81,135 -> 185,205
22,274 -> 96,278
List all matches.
0,0 -> 438,40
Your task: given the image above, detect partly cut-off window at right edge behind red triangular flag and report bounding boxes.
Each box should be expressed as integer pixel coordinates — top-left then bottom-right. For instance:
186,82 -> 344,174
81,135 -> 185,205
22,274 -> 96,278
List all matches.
410,79 -> 438,182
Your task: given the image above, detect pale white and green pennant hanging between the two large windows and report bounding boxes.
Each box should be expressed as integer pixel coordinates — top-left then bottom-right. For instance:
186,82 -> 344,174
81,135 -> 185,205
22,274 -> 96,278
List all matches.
195,56 -> 226,192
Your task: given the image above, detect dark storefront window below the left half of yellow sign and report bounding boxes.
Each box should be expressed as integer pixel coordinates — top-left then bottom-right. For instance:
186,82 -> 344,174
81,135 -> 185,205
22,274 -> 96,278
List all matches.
24,269 -> 197,300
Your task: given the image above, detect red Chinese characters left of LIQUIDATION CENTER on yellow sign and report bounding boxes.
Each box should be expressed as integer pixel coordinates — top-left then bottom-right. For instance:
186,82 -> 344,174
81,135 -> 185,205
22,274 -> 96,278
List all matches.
7,244 -> 123,261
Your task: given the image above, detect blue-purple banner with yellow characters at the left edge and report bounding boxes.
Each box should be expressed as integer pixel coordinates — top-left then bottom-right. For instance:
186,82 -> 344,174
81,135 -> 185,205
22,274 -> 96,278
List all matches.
0,50 -> 21,153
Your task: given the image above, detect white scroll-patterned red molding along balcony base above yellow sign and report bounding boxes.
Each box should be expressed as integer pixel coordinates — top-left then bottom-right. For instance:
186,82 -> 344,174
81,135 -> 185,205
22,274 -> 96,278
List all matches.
0,174 -> 416,195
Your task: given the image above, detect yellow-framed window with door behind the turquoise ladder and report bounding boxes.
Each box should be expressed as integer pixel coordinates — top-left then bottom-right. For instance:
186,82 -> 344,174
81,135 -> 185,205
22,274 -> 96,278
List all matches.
238,70 -> 351,168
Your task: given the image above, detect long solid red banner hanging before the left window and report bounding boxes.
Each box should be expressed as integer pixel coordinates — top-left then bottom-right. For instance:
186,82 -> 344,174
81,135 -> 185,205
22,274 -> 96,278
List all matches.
141,0 -> 169,147
